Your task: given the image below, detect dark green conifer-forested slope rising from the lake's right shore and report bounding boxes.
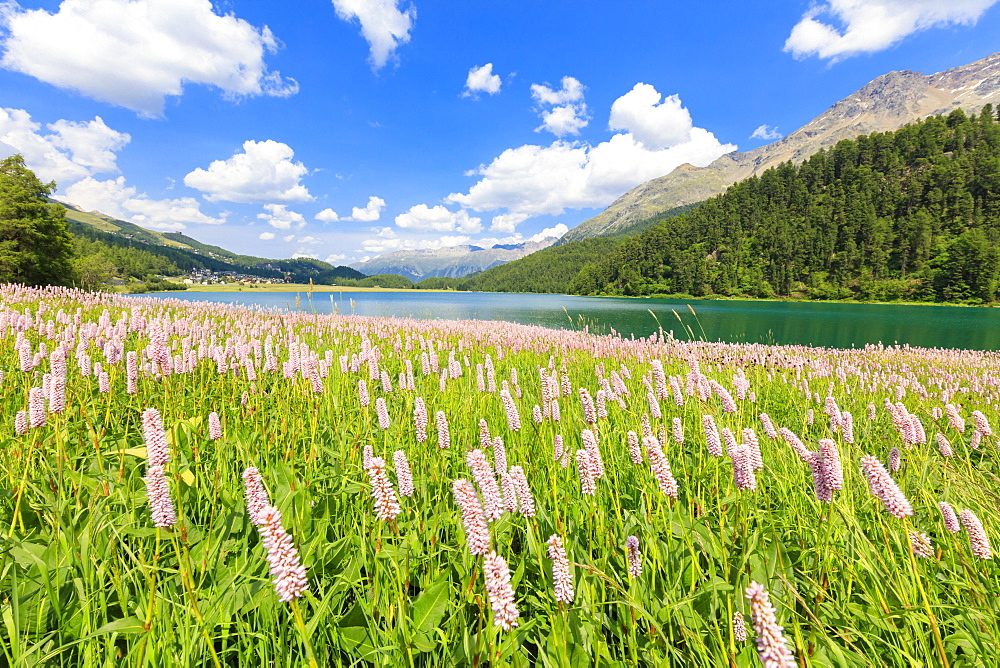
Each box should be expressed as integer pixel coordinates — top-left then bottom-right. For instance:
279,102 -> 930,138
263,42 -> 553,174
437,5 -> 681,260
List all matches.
572,105 -> 1000,303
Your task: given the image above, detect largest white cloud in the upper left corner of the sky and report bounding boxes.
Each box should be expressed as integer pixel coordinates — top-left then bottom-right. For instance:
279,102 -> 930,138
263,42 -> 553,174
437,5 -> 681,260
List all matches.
0,0 -> 298,116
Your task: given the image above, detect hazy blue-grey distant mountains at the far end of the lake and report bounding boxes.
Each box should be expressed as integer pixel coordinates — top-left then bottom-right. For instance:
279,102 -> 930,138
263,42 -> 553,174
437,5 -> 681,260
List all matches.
348,237 -> 556,282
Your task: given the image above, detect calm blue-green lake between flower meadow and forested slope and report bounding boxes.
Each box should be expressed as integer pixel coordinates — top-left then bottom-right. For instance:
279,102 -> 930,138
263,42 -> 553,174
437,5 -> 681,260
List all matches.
139,291 -> 1000,350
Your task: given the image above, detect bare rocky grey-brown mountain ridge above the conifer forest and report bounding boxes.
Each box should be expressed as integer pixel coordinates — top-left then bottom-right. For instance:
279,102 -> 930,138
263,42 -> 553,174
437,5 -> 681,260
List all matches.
559,53 -> 1000,244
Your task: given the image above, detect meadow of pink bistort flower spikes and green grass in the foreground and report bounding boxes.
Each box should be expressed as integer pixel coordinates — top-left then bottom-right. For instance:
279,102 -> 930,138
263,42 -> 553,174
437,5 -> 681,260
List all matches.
0,285 -> 1000,668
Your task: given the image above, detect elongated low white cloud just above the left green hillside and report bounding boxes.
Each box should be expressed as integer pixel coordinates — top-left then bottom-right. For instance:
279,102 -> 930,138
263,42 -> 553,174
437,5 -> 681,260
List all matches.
58,176 -> 226,230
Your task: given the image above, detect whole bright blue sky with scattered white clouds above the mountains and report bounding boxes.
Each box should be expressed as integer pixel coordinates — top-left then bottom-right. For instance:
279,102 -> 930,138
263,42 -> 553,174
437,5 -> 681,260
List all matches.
0,0 -> 1000,264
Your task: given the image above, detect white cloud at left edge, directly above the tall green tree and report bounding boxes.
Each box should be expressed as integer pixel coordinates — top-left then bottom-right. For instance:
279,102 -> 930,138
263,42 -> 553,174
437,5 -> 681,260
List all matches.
0,108 -> 131,186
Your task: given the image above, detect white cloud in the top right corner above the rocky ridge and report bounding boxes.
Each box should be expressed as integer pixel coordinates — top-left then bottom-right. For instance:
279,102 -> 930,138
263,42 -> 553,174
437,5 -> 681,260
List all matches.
785,0 -> 997,60
